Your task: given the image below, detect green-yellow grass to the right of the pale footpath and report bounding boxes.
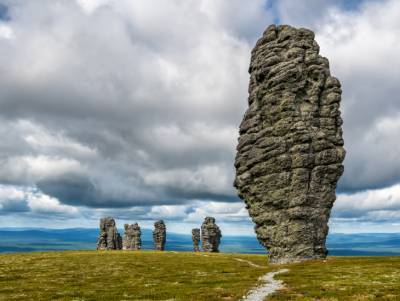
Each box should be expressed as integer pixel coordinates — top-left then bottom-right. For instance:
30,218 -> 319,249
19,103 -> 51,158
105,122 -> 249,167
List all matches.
268,256 -> 400,301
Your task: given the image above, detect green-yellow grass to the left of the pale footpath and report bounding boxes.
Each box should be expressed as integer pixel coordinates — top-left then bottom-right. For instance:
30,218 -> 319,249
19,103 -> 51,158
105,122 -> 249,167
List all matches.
0,251 -> 269,301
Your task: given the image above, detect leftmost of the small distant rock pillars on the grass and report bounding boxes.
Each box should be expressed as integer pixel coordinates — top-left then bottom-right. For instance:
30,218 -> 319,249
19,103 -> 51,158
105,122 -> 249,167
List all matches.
97,217 -> 122,250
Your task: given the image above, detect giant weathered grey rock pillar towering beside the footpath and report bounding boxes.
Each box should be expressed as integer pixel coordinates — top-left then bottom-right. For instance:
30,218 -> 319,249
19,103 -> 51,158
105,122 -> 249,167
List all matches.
234,25 -> 345,263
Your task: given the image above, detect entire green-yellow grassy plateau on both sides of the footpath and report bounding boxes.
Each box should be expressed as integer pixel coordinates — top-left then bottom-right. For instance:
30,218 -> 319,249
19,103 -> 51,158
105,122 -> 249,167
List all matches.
0,251 -> 400,301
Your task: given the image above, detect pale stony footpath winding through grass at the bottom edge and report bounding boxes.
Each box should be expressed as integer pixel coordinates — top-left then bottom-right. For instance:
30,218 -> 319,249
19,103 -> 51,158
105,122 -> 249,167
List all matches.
242,269 -> 289,301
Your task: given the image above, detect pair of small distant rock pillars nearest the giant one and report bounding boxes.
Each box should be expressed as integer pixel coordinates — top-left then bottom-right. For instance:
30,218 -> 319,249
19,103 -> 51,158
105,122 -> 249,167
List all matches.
192,217 -> 222,252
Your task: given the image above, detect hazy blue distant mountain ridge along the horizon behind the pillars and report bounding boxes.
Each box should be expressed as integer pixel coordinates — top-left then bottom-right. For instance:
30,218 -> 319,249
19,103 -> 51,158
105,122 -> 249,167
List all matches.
0,228 -> 400,256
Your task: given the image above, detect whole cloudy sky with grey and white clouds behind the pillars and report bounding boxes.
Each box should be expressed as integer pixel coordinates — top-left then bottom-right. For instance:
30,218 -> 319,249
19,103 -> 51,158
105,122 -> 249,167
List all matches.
0,0 -> 400,235
